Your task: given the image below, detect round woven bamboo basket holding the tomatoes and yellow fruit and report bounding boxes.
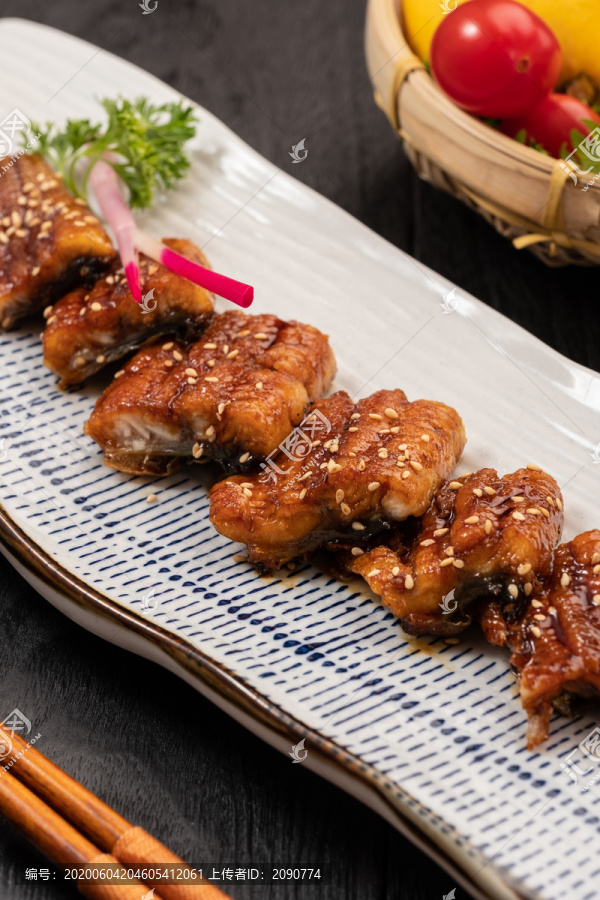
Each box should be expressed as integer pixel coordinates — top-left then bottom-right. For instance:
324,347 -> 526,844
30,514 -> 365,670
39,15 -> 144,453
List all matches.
365,0 -> 600,266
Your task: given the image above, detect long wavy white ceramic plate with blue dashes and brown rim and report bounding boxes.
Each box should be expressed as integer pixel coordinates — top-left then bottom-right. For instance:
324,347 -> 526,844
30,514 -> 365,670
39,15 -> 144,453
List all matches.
0,20 -> 600,900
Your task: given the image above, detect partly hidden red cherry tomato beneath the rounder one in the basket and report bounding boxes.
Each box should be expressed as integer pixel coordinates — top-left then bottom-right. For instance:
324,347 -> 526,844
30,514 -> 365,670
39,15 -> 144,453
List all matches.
500,94 -> 600,159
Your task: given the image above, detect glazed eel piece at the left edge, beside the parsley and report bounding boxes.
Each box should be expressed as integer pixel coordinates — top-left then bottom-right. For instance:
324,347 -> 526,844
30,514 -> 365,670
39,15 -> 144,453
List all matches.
0,154 -> 115,330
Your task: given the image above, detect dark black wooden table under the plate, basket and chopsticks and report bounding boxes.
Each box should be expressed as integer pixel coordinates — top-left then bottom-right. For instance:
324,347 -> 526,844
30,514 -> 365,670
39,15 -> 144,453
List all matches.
0,0 -> 600,900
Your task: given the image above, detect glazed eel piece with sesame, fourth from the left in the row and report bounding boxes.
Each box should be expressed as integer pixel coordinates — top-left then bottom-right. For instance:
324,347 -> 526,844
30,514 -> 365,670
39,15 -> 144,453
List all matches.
210,390 -> 465,571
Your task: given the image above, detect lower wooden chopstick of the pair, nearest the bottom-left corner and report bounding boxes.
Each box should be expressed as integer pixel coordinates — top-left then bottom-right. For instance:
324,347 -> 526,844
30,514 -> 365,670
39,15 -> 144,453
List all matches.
0,772 -> 160,900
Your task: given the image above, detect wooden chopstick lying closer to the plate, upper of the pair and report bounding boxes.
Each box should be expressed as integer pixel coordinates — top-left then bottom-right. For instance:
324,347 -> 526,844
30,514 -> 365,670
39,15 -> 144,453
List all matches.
0,727 -> 229,900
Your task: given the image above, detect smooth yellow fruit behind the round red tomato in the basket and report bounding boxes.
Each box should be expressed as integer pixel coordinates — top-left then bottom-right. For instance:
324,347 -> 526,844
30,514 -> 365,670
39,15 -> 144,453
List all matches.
402,0 -> 600,89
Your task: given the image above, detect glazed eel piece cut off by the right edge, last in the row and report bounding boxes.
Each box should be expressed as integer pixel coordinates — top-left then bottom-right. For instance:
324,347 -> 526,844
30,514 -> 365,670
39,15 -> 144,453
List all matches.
479,530 -> 600,750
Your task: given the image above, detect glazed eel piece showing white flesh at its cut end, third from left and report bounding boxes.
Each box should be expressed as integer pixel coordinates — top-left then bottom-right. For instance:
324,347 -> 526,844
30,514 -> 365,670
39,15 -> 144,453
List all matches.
84,310 -> 335,475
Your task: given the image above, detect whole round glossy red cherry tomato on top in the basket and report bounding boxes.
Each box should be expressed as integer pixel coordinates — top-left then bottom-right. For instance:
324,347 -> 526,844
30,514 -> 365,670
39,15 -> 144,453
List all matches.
430,0 -> 562,119
